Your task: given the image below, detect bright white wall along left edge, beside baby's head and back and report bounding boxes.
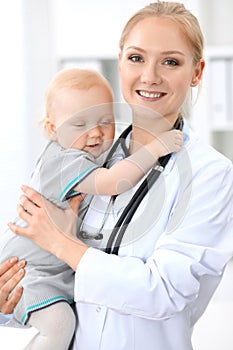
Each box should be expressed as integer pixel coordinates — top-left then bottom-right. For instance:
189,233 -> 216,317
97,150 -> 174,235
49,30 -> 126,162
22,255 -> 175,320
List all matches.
0,0 -> 56,230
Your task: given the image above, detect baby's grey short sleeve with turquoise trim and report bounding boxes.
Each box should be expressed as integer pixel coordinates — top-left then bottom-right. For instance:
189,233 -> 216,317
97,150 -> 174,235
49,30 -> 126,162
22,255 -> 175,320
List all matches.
38,144 -> 99,204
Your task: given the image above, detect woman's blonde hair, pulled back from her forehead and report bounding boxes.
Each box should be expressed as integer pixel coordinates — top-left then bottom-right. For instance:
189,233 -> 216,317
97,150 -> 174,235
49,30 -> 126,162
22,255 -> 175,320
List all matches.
119,0 -> 204,64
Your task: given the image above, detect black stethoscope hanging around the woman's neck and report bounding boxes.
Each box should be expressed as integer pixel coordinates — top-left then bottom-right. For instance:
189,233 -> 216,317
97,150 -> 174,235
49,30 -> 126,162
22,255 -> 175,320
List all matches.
78,117 -> 183,255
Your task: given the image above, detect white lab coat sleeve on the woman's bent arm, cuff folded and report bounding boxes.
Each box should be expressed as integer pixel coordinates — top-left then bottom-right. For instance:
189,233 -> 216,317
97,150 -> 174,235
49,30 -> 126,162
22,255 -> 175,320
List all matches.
75,158 -> 233,319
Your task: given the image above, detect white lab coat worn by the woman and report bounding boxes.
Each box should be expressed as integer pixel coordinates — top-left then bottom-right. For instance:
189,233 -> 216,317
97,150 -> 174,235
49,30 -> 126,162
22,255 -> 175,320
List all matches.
73,123 -> 233,350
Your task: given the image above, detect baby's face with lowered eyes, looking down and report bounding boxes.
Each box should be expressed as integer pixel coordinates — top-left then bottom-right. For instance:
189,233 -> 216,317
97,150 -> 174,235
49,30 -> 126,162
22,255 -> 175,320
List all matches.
53,86 -> 115,158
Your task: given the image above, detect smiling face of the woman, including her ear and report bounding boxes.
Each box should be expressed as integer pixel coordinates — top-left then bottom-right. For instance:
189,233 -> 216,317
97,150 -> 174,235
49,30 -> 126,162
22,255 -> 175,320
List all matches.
119,16 -> 204,124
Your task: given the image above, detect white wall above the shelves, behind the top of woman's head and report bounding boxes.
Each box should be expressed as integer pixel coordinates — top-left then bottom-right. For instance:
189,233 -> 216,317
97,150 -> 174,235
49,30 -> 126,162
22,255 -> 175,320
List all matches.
50,0 -> 200,58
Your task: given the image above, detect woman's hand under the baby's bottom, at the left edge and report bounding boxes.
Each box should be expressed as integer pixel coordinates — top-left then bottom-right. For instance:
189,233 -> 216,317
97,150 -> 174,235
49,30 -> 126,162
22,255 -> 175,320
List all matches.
0,257 -> 25,315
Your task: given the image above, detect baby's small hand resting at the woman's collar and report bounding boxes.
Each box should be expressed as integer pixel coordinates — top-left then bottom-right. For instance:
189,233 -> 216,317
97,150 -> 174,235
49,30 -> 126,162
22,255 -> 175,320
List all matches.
157,129 -> 183,157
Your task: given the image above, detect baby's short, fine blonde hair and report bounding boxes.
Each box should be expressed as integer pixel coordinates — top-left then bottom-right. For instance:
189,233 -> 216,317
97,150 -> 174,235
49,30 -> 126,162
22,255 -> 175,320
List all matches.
40,68 -> 113,138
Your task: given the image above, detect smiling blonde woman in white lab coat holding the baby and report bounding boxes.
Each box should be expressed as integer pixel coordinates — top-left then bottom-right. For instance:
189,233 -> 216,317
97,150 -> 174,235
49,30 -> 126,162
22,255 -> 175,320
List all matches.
0,2 -> 233,350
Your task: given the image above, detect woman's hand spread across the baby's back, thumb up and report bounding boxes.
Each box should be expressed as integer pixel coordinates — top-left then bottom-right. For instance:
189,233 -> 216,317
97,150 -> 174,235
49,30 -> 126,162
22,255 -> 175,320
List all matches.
8,186 -> 88,270
